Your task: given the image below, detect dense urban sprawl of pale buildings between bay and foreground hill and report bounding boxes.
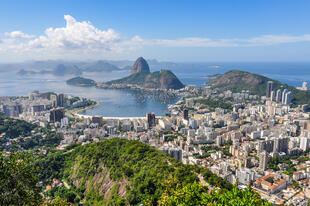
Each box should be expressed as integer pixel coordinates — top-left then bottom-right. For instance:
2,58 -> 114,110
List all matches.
0,81 -> 310,205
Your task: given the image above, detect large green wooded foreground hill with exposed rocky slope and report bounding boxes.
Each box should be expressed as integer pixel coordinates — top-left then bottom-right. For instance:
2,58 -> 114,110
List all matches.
36,138 -> 263,205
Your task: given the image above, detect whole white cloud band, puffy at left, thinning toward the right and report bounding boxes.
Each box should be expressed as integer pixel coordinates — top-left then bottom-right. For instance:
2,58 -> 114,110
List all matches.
0,15 -> 310,57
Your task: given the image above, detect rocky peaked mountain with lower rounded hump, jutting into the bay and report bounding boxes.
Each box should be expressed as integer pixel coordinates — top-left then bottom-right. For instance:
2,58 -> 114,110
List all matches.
107,57 -> 184,89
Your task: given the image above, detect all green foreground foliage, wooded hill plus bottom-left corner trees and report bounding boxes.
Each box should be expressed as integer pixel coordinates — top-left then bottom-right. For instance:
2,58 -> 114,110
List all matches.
0,138 -> 269,206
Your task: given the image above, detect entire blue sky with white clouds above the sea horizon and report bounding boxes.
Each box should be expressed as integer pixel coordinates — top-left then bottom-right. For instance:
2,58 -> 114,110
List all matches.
0,0 -> 310,62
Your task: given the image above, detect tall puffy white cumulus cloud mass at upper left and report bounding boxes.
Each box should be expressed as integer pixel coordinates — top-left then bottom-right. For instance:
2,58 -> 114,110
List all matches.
23,15 -> 120,50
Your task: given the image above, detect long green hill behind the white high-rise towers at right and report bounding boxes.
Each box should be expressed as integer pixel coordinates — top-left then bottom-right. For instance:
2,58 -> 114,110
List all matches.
207,70 -> 310,106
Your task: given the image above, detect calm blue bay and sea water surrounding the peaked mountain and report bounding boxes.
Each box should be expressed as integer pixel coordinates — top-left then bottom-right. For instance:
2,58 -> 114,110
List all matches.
0,62 -> 310,117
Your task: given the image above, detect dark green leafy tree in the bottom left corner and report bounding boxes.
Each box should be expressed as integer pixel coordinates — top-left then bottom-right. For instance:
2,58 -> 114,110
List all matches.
0,152 -> 42,205
